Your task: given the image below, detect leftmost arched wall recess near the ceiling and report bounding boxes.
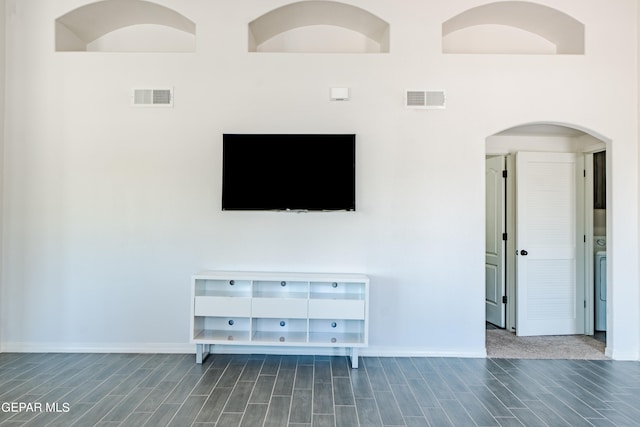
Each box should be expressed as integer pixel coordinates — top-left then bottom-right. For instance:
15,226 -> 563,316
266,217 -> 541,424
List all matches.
56,0 -> 196,52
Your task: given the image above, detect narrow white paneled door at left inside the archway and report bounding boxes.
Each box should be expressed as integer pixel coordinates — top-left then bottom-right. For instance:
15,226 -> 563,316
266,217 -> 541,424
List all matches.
484,156 -> 505,328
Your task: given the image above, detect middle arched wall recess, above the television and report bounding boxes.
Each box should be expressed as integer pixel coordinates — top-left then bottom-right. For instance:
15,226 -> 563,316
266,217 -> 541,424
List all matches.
249,1 -> 389,53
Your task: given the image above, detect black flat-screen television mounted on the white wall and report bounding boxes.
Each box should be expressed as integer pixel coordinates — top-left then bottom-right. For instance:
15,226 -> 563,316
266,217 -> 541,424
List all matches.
222,134 -> 356,211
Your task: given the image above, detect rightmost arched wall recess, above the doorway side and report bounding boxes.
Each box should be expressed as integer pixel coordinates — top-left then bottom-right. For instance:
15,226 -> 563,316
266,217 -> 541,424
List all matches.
442,1 -> 585,55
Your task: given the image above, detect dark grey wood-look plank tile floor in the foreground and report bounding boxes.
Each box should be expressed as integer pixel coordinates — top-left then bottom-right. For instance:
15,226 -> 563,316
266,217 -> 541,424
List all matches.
0,354 -> 640,427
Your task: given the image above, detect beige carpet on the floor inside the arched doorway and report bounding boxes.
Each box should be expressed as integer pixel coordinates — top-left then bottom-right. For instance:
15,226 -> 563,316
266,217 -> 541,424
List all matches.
486,329 -> 608,360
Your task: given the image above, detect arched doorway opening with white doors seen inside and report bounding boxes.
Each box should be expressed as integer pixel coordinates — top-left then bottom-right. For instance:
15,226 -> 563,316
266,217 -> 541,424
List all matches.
485,123 -> 611,358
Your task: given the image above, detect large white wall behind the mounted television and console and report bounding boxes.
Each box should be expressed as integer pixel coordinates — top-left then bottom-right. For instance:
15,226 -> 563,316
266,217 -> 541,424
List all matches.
0,0 -> 640,359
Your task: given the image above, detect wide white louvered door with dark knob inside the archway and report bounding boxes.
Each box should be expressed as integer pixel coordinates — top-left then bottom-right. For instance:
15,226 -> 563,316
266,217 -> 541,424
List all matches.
516,152 -> 584,336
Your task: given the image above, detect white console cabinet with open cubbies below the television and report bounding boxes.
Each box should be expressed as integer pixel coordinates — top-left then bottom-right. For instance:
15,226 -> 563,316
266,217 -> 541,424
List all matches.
191,271 -> 369,368
